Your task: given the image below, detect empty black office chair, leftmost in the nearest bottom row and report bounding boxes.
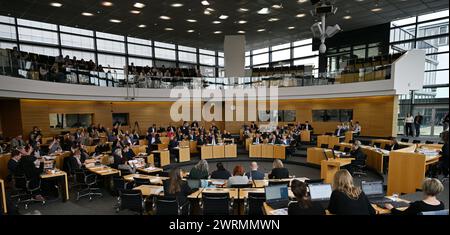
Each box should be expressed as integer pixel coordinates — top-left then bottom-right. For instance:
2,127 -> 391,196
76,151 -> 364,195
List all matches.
116,189 -> 145,215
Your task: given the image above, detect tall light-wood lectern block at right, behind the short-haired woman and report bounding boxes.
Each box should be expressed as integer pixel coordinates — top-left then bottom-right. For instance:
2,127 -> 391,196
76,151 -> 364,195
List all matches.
387,145 -> 441,195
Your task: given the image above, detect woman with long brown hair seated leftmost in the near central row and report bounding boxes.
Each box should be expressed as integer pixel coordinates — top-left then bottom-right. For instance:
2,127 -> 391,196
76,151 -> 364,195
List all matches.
163,168 -> 192,205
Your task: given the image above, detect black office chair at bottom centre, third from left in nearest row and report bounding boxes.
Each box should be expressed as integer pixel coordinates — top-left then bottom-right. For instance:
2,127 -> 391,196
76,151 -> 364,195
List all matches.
200,193 -> 233,215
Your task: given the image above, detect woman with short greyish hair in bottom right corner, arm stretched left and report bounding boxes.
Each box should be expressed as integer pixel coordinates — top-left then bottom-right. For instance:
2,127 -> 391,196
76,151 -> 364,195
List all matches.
385,178 -> 445,215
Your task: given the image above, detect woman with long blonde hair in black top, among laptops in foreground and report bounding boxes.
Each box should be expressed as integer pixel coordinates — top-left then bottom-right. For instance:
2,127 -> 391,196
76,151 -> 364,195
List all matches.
328,170 -> 375,215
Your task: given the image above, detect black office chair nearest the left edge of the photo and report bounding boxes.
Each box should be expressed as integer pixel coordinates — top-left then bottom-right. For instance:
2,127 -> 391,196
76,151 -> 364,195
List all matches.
13,175 -> 45,210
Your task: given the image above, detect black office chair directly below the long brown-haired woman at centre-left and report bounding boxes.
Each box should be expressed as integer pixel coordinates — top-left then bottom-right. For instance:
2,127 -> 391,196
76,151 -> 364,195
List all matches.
153,196 -> 191,215
